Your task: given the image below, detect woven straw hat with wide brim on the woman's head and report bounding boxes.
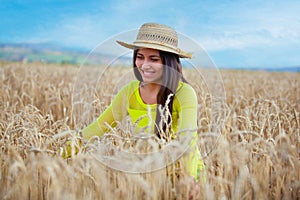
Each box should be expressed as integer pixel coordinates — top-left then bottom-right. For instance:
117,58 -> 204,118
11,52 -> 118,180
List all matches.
117,23 -> 192,58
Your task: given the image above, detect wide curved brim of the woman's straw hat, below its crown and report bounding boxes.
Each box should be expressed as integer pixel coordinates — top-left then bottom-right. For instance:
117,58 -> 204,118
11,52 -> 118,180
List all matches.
117,40 -> 192,58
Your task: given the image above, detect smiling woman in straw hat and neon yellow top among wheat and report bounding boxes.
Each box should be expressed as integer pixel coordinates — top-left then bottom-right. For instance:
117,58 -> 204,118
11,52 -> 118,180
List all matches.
62,23 -> 203,180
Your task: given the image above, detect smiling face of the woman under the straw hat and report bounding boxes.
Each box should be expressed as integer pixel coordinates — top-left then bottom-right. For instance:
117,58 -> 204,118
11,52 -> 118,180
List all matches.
135,48 -> 163,83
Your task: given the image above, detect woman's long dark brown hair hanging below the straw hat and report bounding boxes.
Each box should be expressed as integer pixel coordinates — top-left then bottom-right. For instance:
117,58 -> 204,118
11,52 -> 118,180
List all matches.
133,49 -> 187,139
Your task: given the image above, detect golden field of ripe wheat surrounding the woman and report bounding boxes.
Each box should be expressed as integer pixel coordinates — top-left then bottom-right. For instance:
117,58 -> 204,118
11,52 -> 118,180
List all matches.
0,62 -> 300,199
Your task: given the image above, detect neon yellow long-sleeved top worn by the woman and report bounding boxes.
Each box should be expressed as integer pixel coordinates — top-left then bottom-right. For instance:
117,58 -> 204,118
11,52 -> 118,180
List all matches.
82,80 -> 203,179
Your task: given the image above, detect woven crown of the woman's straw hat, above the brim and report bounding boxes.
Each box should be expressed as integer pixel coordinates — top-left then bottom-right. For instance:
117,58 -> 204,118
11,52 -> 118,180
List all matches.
135,23 -> 178,48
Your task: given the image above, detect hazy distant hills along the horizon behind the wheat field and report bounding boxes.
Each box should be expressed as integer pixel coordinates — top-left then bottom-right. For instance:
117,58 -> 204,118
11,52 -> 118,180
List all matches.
0,43 -> 300,72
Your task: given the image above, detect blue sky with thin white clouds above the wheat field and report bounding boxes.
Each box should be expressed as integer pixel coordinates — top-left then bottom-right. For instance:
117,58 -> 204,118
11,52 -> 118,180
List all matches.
0,0 -> 300,68
